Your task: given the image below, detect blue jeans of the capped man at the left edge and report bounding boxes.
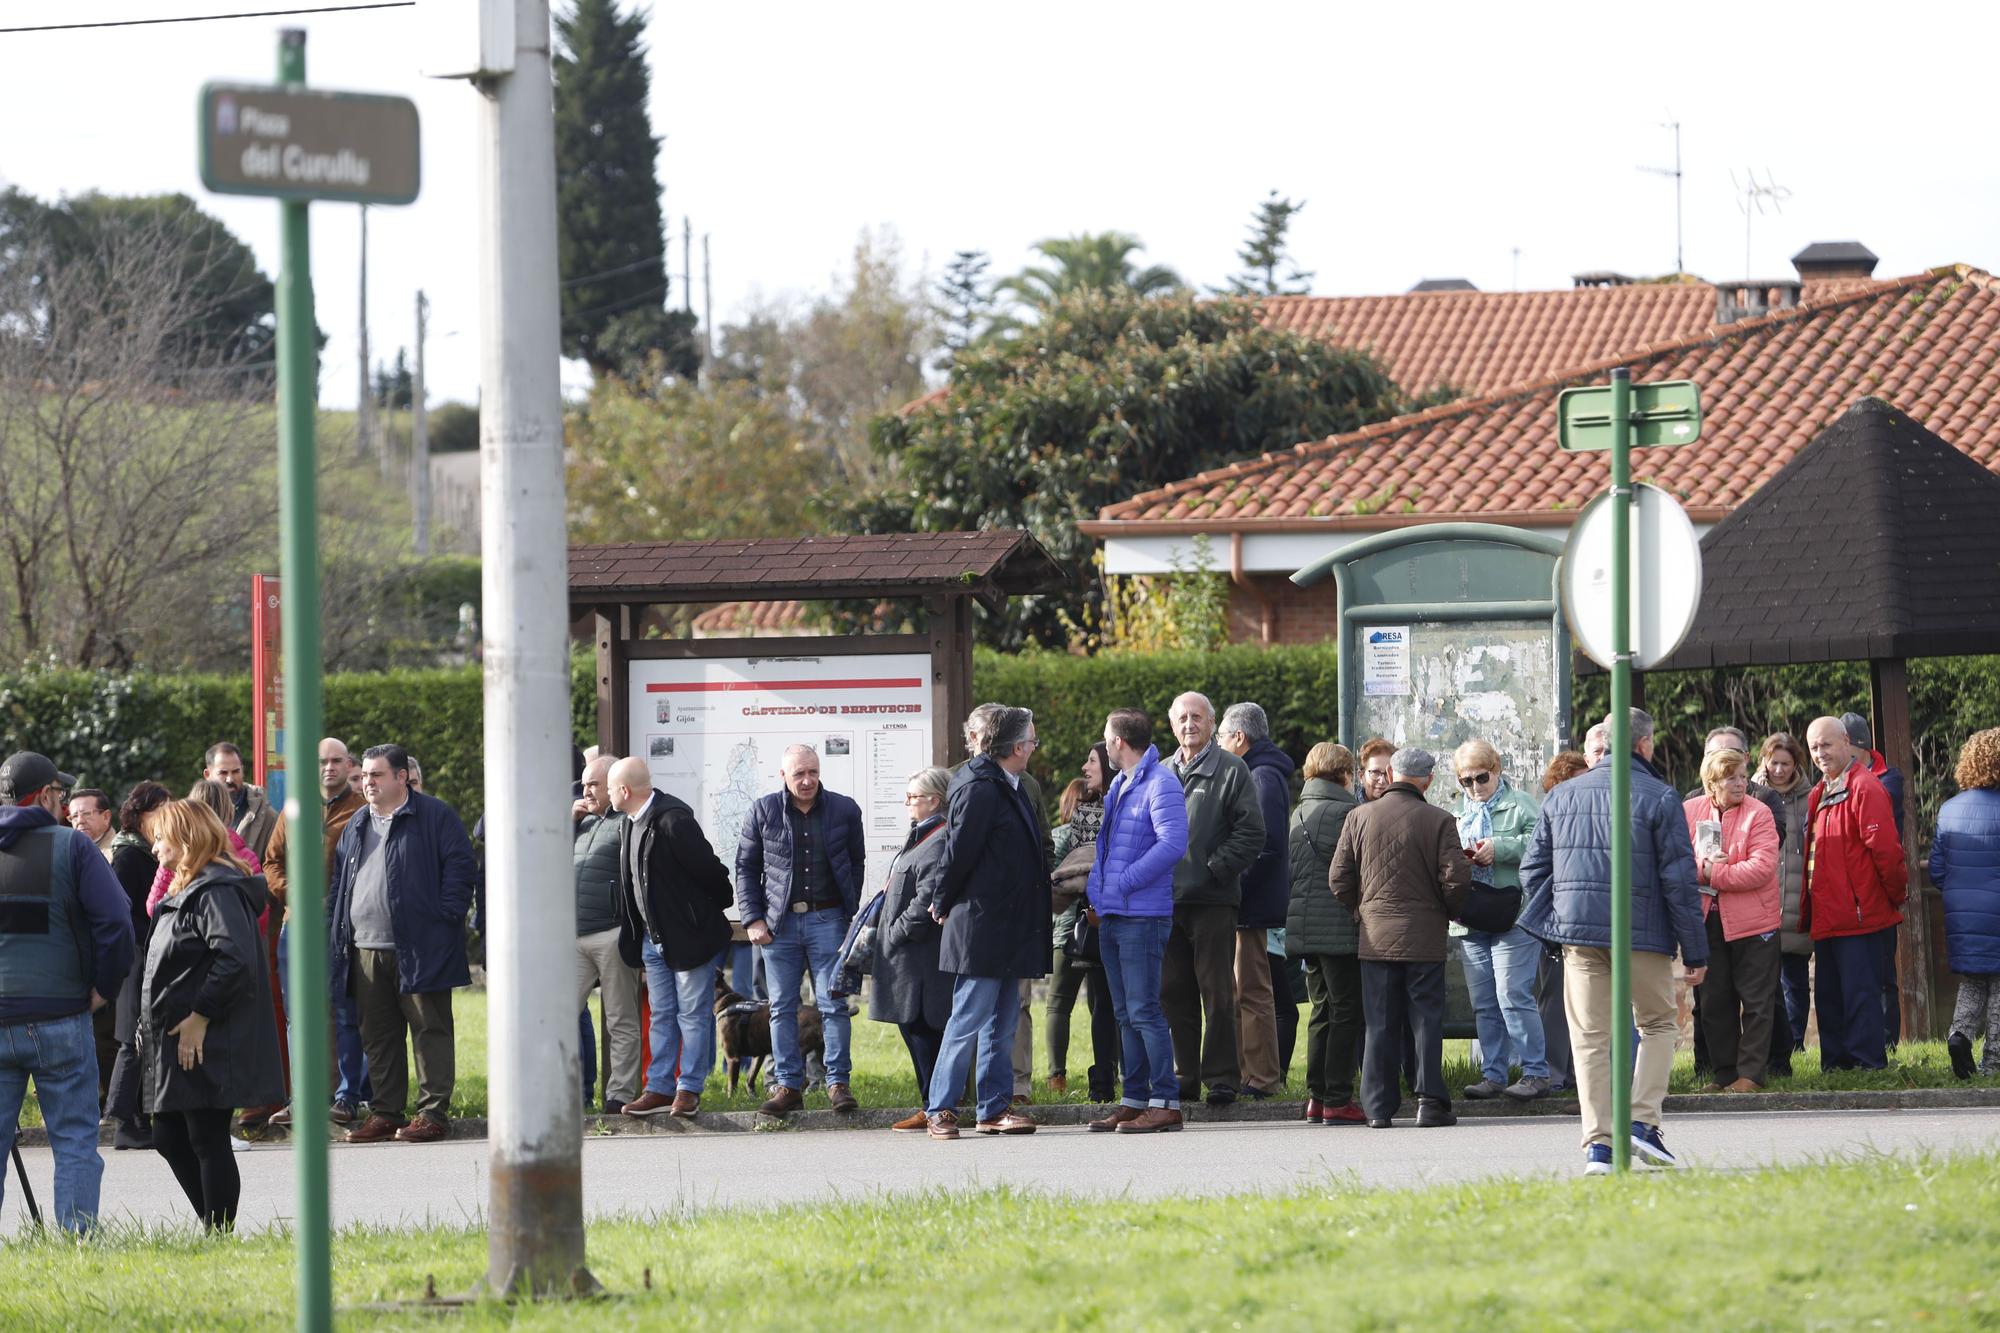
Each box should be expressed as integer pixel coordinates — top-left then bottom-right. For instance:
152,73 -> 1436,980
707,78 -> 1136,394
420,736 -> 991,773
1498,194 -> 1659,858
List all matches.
0,1013 -> 104,1233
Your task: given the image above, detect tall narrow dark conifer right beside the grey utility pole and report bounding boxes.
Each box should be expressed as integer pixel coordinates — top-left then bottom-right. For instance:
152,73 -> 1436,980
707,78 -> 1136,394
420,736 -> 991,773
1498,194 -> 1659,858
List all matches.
554,0 -> 702,378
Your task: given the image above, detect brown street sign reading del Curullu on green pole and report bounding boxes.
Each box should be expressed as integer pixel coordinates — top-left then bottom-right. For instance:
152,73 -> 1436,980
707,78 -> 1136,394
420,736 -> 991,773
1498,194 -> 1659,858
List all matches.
200,84 -> 422,204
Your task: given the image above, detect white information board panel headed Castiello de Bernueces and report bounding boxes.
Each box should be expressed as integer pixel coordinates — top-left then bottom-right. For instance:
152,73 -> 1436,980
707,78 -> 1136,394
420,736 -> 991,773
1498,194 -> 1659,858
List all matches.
630,652 -> 932,872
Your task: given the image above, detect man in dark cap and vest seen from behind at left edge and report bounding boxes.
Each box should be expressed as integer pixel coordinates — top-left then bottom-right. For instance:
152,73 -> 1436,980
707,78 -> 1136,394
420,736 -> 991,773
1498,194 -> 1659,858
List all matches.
0,753 -> 132,1231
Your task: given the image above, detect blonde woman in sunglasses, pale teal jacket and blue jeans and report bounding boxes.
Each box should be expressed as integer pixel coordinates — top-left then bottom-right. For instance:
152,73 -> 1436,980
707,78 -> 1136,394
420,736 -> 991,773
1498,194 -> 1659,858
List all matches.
1452,741 -> 1548,1101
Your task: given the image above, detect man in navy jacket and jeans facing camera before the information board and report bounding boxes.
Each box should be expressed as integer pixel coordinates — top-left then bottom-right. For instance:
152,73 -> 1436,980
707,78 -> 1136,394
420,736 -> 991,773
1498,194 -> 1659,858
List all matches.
736,745 -> 868,1117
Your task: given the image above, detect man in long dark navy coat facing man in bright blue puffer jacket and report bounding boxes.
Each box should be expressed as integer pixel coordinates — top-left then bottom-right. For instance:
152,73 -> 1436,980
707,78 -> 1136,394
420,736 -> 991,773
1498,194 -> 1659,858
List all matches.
918,709 -> 1050,1139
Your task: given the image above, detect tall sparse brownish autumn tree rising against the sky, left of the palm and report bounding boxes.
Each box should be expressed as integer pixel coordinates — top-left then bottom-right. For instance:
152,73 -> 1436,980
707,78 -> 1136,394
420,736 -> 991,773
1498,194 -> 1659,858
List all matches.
716,228 -> 936,488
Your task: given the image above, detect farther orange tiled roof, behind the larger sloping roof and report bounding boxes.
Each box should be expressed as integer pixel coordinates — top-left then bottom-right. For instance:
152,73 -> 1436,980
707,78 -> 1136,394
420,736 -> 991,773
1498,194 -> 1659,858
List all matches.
1264,282 -> 1716,394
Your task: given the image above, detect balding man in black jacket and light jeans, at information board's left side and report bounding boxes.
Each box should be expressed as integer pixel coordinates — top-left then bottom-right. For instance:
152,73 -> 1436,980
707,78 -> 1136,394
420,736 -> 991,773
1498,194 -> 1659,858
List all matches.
606,757 -> 730,1119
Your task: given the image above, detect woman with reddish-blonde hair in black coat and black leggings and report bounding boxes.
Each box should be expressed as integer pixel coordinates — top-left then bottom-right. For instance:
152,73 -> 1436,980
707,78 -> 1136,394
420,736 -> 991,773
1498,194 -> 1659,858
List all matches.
138,801 -> 284,1229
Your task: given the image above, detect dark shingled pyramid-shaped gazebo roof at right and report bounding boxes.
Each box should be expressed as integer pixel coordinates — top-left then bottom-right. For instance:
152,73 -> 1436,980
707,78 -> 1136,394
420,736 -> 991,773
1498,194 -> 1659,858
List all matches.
1654,398 -> 2000,671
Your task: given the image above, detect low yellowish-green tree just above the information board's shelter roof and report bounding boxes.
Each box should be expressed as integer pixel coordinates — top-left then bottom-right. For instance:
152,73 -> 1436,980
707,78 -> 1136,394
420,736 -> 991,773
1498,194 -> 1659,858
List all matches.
564,368 -> 826,542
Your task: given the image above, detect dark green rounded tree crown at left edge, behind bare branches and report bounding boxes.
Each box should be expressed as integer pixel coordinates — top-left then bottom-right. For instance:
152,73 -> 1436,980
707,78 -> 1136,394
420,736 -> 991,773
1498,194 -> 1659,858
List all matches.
0,188 -> 278,378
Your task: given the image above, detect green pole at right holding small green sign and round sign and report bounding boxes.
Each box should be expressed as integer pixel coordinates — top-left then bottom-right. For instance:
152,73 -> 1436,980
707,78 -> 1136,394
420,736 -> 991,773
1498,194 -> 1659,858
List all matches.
1610,366 -> 1632,1173
